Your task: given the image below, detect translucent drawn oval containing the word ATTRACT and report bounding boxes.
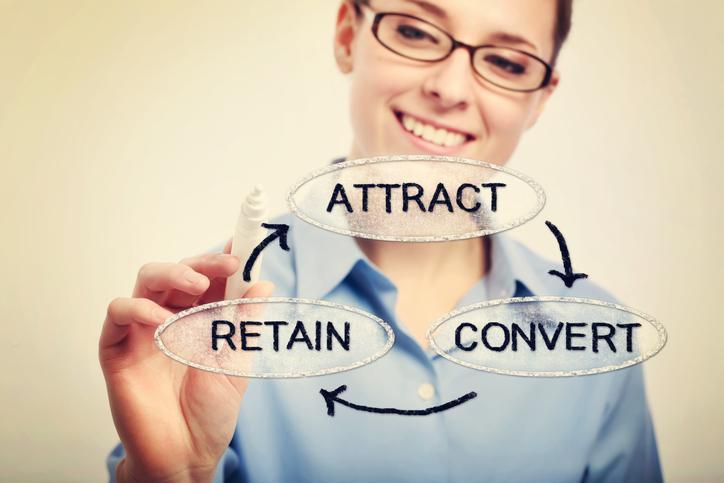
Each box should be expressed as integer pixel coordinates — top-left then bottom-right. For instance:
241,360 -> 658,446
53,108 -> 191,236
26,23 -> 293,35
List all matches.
287,155 -> 545,242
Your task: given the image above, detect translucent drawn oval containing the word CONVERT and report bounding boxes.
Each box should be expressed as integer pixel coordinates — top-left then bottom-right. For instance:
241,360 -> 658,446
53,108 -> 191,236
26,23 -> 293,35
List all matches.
427,297 -> 667,377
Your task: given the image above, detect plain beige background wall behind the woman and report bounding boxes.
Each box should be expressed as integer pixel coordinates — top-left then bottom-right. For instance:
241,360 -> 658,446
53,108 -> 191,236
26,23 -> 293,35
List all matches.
0,0 -> 724,482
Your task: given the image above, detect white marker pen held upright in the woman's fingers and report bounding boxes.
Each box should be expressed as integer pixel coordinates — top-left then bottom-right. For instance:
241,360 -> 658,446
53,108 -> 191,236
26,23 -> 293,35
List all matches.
224,185 -> 268,300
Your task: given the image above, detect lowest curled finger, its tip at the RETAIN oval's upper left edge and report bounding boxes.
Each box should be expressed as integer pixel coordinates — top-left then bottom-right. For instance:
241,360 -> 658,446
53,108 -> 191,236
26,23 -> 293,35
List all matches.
99,297 -> 173,350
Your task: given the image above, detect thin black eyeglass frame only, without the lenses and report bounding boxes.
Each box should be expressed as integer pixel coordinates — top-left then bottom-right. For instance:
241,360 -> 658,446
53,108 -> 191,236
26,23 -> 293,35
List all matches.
364,8 -> 553,92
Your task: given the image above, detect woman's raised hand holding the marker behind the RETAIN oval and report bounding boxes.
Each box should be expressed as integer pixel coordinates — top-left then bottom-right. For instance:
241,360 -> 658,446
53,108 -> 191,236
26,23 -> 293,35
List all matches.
99,241 -> 274,481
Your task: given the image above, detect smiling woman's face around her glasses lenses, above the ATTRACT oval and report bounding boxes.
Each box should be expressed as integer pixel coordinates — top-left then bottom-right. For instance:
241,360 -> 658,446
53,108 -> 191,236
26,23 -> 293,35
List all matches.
335,0 -> 558,164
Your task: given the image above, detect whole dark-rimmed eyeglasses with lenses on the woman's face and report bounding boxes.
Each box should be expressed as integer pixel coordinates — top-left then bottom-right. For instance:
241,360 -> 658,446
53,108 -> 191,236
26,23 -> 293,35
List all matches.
355,2 -> 553,92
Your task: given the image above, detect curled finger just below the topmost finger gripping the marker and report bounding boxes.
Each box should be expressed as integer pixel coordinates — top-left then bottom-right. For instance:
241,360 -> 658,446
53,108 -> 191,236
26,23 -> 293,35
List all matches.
133,262 -> 210,304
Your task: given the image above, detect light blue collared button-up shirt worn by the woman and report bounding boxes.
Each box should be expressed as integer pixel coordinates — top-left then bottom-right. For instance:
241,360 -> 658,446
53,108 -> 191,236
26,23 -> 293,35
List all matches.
108,210 -> 662,483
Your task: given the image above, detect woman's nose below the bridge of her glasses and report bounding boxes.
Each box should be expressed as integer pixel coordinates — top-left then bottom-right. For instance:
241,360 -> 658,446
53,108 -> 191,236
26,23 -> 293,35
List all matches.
422,49 -> 475,110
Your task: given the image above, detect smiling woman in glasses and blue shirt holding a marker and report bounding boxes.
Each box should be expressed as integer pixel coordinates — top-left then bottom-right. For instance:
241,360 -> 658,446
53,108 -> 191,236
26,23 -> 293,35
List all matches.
100,0 -> 661,482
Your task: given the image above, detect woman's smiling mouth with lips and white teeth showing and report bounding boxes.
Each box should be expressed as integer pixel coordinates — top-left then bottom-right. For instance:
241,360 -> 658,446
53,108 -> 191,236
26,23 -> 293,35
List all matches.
394,110 -> 475,154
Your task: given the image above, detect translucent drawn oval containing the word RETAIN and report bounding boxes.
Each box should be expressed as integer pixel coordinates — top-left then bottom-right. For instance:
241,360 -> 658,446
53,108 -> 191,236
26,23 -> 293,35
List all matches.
155,297 -> 395,378
